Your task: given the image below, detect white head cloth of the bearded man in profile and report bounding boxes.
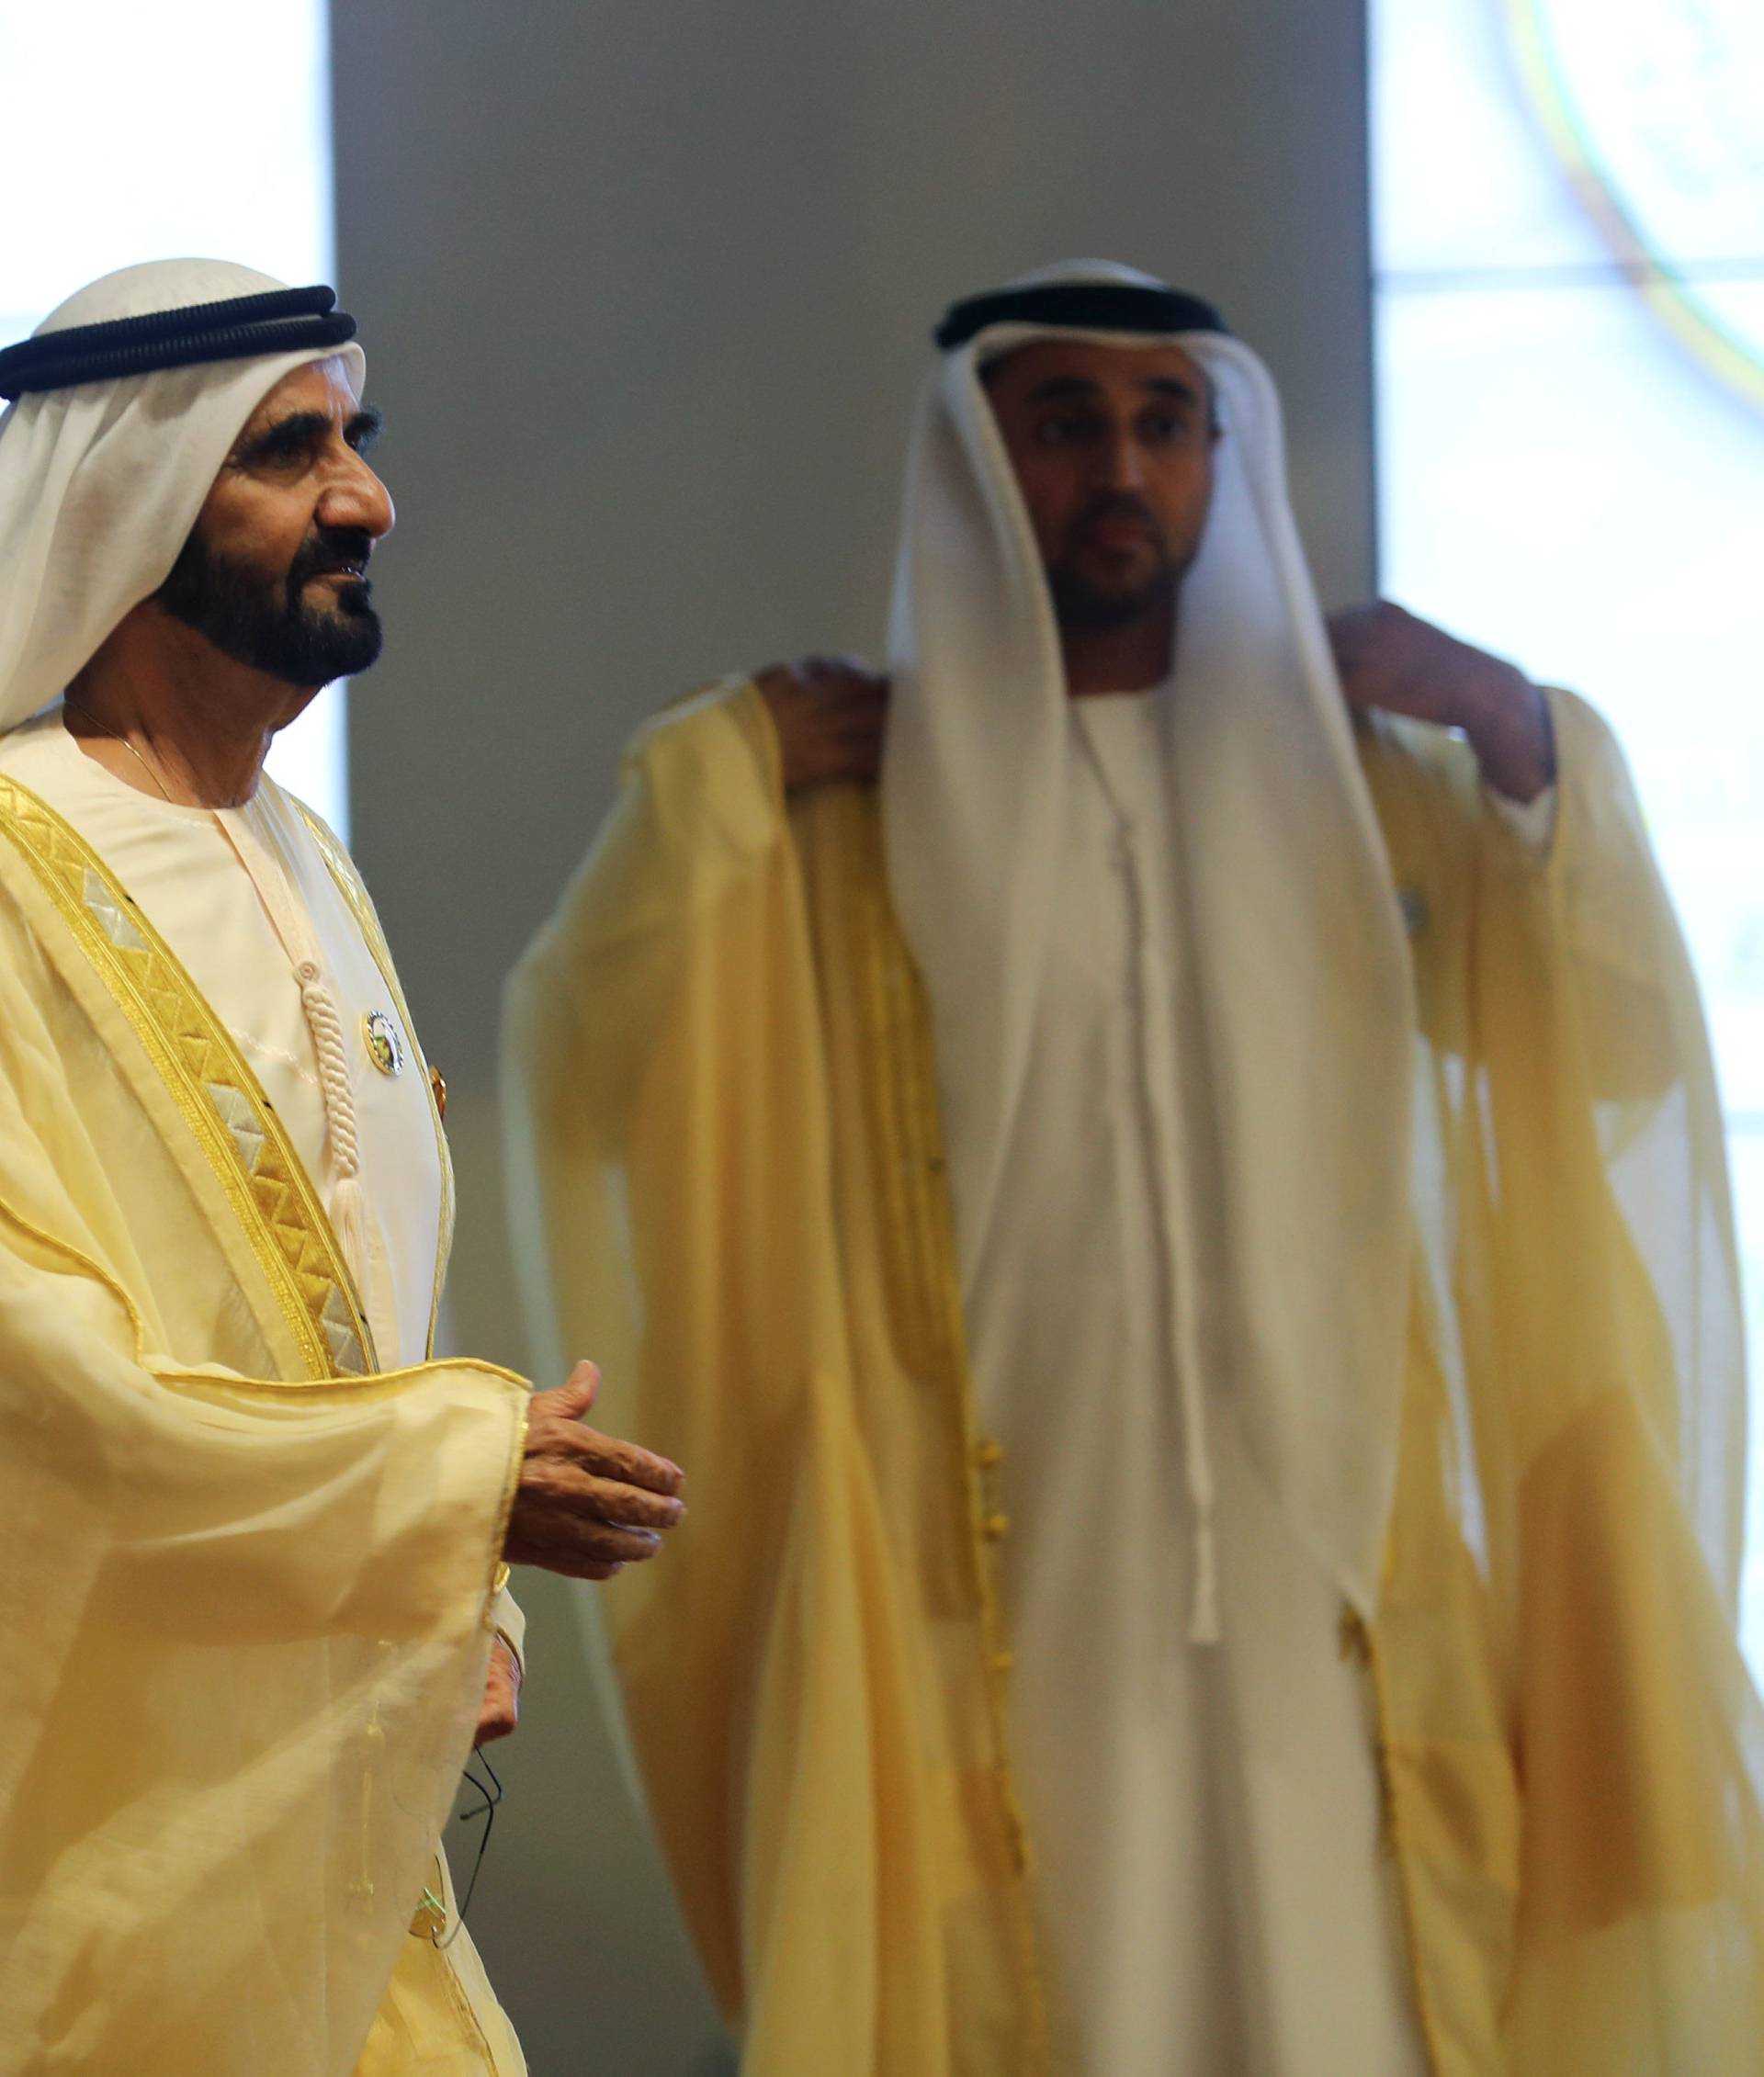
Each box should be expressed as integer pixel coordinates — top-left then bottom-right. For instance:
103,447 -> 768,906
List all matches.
0,260 -> 366,729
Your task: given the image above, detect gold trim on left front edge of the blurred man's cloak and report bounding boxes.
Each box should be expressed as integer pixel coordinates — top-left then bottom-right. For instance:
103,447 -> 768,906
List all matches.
845,796 -> 1049,2077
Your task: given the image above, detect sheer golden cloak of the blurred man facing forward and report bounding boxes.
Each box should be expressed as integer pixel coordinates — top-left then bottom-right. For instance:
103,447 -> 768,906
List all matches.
507,687 -> 1764,2077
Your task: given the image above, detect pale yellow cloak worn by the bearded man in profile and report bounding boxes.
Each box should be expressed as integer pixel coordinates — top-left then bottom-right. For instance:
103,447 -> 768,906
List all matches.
0,777 -> 526,2077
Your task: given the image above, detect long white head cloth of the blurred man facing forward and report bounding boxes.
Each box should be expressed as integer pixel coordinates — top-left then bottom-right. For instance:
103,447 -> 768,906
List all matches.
883,262 -> 1413,1614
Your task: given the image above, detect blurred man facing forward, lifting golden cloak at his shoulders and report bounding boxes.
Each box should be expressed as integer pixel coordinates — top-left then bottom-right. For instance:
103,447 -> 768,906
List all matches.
509,265 -> 1764,2077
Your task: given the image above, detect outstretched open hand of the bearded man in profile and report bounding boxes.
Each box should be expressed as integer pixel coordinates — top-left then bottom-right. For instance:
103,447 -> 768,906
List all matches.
503,1362 -> 685,1578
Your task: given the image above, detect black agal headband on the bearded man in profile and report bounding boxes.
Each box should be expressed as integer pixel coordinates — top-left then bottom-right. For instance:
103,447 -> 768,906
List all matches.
0,287 -> 356,403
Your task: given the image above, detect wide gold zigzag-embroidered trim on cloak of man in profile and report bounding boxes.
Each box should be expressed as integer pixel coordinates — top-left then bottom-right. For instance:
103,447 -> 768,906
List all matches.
0,774 -> 374,1379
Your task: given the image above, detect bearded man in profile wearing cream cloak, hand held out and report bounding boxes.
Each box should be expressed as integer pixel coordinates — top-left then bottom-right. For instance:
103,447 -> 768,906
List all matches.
0,262 -> 682,2077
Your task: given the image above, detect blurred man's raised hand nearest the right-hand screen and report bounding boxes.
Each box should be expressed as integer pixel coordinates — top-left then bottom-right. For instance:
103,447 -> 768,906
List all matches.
1328,598 -> 1556,802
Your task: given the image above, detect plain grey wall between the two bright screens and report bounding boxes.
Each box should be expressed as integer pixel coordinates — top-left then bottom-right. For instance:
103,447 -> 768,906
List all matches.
334,0 -> 1372,2077
